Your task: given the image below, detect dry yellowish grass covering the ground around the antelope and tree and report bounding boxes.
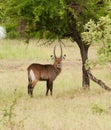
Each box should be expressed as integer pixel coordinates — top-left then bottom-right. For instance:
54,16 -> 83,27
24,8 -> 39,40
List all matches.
0,39 -> 111,130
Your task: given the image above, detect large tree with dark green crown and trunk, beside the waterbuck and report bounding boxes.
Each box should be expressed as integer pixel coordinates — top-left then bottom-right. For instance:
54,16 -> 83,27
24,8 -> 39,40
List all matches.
3,0 -> 110,88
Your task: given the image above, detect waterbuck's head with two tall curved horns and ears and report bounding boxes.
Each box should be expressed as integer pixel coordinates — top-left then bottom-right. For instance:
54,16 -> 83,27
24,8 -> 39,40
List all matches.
51,43 -> 66,69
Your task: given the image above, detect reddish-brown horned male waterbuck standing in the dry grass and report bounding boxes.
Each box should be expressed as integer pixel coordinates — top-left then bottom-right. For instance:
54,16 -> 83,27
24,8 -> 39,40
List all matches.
27,44 -> 66,96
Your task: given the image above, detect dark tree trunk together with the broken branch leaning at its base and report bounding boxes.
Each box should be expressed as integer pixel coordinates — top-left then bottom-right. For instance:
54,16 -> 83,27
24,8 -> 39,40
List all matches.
65,4 -> 111,91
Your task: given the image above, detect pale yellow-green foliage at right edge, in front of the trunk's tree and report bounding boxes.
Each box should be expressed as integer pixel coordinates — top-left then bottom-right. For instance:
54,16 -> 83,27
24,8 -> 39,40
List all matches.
82,16 -> 111,61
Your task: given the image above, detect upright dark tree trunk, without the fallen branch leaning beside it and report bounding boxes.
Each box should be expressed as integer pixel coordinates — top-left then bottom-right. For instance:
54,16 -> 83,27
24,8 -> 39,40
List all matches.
67,11 -> 90,89
